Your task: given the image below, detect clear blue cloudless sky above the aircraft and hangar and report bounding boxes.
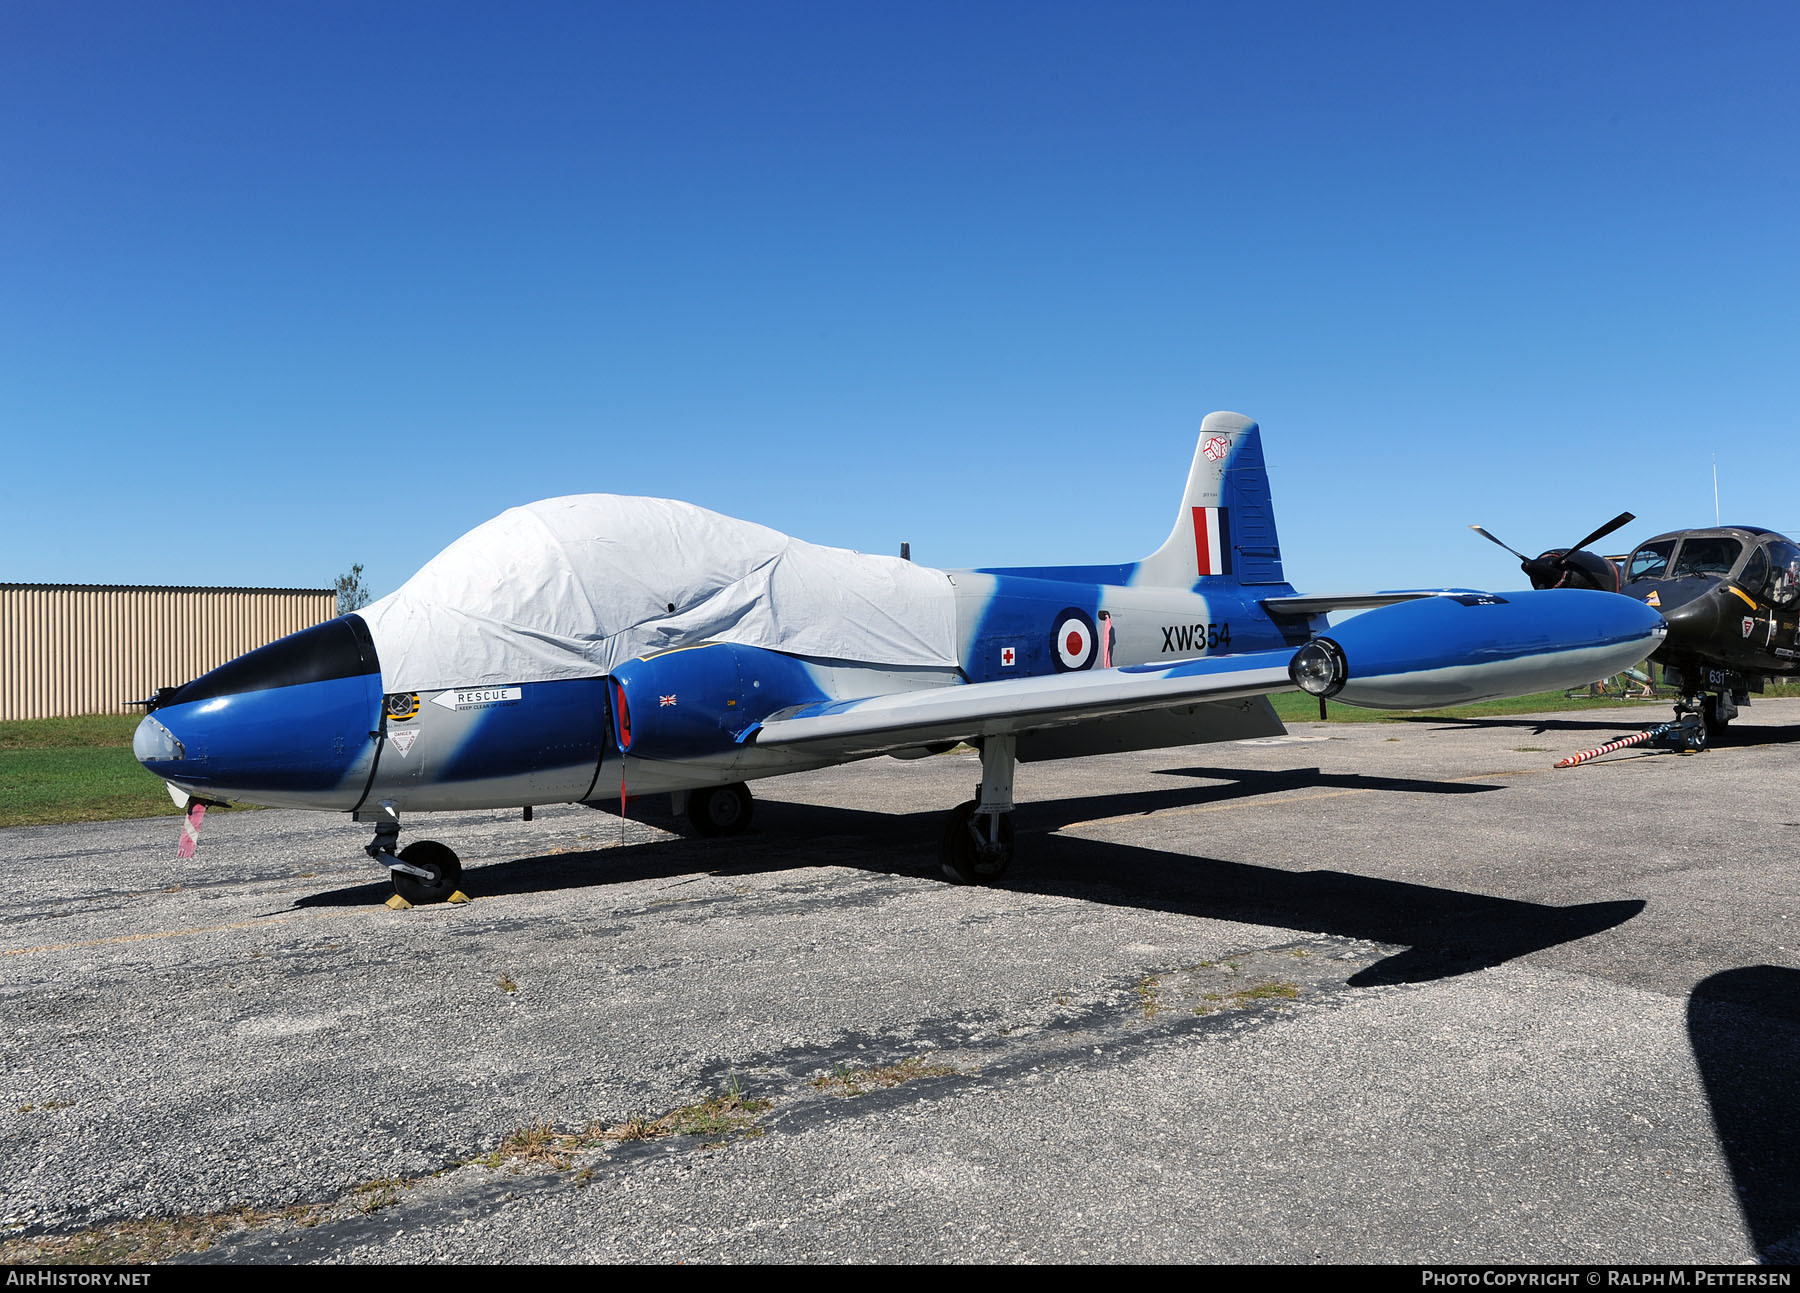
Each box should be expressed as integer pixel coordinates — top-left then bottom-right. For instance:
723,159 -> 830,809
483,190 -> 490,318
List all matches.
0,0 -> 1800,592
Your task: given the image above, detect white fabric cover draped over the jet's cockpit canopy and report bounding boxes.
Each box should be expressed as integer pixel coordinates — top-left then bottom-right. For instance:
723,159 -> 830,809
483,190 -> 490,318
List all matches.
358,493 -> 958,692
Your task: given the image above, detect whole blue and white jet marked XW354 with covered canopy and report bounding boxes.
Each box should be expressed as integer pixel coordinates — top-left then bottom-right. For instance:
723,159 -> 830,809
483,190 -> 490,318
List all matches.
133,412 -> 1665,902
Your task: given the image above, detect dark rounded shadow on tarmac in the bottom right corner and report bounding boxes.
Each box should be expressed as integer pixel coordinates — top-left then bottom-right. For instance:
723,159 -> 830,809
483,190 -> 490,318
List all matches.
1688,965 -> 1800,1264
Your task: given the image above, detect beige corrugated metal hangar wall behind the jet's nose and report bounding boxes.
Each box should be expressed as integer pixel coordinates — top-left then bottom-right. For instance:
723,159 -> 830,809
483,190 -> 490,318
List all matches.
0,583 -> 337,719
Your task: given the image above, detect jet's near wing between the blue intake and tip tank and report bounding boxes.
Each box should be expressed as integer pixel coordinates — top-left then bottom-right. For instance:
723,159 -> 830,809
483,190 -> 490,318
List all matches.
743,647 -> 1298,758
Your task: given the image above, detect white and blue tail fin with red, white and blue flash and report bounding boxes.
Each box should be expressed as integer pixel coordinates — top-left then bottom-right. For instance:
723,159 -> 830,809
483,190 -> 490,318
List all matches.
1132,412 -> 1283,589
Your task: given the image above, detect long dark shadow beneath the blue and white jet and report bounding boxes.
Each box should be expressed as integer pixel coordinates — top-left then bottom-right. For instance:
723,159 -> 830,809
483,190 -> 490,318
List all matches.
297,767 -> 1645,987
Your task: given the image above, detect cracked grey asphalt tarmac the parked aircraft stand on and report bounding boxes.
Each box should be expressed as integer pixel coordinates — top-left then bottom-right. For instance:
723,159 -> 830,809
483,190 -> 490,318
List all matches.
0,701 -> 1800,1264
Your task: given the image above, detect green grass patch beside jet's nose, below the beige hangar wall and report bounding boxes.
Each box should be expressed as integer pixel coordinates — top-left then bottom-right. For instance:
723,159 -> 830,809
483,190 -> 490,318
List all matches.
0,713 -> 178,827
